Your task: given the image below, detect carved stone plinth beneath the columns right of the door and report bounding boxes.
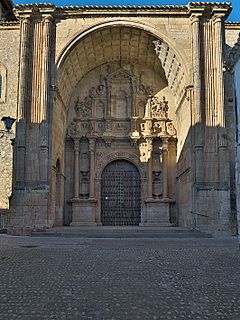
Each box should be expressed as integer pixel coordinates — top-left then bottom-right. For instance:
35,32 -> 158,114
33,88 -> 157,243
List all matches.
140,199 -> 172,227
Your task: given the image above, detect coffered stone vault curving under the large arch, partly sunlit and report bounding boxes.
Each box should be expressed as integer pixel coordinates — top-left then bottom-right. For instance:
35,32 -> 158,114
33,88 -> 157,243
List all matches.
57,21 -> 187,110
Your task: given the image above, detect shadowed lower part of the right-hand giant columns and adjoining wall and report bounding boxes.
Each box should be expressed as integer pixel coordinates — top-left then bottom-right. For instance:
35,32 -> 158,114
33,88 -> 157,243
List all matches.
175,124 -> 237,234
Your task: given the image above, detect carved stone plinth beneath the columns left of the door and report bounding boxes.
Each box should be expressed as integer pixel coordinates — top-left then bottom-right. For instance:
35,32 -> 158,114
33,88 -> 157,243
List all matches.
71,198 -> 97,227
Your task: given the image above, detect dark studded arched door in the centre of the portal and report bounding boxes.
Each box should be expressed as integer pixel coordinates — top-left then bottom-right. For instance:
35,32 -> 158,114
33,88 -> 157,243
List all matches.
101,160 -> 141,226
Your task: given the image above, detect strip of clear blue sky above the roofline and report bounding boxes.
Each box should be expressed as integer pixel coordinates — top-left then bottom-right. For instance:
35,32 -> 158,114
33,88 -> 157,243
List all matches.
13,0 -> 240,21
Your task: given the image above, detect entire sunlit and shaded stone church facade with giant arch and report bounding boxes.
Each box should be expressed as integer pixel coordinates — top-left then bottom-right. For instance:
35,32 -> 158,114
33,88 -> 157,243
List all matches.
0,1 -> 240,234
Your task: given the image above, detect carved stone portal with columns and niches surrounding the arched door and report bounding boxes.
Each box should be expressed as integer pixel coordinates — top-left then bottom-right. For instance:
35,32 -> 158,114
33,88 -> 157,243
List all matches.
67,68 -> 176,226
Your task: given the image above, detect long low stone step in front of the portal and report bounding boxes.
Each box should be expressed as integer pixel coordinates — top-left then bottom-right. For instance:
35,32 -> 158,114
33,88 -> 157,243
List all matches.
32,227 -> 212,239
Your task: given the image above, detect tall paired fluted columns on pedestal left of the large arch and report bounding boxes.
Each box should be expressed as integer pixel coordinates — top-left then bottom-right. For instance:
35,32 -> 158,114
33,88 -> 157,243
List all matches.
9,4 -> 56,234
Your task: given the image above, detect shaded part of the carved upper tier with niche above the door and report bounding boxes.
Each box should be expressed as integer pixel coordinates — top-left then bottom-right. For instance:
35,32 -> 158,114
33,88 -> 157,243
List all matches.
68,68 -> 154,141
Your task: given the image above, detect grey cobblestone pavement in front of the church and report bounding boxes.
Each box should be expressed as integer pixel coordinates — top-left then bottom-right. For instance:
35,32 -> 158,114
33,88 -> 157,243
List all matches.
0,235 -> 240,320
